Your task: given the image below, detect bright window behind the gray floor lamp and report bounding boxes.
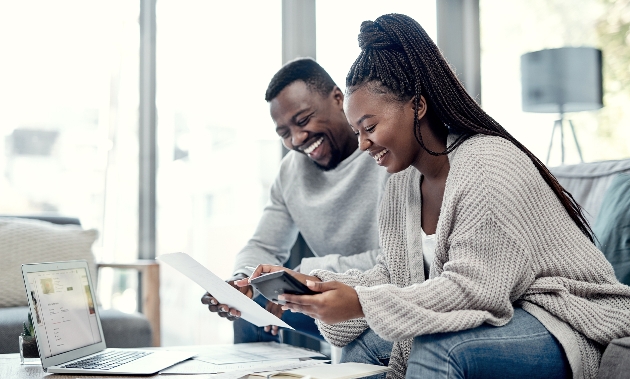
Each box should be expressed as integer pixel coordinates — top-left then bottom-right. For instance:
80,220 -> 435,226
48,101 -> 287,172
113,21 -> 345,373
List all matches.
480,0 -> 630,166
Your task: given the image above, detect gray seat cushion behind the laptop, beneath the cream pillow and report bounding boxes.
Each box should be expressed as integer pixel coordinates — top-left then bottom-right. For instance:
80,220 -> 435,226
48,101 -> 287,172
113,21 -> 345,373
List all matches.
0,307 -> 152,354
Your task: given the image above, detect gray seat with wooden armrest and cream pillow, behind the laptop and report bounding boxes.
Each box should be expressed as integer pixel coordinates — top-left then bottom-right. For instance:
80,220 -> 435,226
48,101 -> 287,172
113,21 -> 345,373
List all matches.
0,216 -> 160,354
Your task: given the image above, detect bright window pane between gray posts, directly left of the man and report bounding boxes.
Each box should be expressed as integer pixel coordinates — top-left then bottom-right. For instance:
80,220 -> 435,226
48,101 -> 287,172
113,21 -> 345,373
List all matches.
156,0 -> 282,346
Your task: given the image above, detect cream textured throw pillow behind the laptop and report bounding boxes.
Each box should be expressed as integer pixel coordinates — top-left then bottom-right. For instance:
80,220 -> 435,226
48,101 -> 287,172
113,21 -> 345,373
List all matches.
0,218 -> 98,308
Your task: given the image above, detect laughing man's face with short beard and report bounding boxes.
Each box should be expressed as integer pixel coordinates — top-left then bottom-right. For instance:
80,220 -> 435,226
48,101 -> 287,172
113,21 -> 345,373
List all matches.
269,80 -> 357,170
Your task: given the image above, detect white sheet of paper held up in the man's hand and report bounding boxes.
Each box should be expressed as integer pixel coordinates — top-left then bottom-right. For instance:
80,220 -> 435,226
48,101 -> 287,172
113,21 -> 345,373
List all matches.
157,253 -> 293,329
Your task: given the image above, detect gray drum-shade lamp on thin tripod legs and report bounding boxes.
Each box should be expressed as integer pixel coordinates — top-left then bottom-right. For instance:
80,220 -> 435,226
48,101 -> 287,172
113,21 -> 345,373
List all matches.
521,47 -> 604,164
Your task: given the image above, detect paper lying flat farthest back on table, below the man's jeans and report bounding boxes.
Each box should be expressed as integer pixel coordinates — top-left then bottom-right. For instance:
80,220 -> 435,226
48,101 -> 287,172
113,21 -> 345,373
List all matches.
194,342 -> 326,365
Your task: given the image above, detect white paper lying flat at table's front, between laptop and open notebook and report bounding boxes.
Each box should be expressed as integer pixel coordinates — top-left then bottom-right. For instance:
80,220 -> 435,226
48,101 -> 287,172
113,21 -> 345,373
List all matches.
160,360 -> 324,377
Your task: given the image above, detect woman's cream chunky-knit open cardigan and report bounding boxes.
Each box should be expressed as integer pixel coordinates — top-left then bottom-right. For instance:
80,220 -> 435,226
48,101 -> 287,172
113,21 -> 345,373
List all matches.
311,135 -> 630,379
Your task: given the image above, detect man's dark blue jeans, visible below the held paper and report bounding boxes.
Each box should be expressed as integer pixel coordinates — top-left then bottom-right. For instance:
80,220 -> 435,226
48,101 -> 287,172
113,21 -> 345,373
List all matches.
234,295 -> 324,343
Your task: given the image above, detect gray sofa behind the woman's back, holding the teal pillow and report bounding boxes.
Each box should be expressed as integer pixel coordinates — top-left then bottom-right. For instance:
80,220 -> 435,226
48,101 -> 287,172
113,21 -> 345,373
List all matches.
550,159 -> 630,379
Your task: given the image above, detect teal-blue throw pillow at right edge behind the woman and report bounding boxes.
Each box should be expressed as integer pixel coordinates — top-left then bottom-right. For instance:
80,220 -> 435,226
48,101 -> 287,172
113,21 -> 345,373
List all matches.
593,174 -> 630,285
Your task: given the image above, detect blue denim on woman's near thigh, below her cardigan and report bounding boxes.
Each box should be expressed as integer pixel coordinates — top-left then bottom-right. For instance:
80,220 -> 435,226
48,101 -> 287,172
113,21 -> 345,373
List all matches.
406,308 -> 572,379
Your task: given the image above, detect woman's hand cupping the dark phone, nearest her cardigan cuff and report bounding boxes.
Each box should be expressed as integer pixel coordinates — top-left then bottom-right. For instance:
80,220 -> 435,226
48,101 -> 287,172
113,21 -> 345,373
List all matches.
278,279 -> 365,324
